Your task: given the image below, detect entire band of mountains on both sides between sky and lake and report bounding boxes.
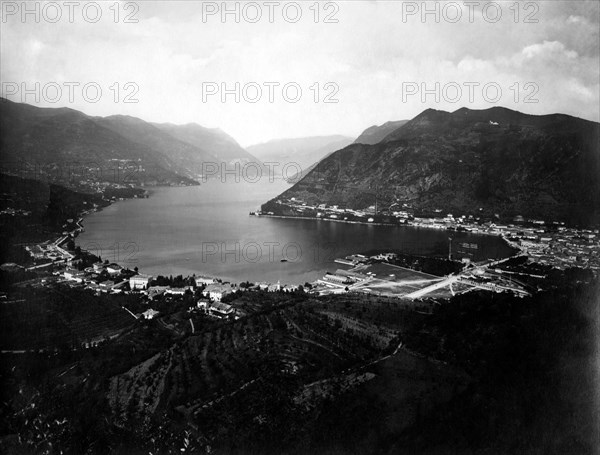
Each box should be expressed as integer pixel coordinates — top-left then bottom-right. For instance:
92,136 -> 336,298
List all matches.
0,98 -> 600,227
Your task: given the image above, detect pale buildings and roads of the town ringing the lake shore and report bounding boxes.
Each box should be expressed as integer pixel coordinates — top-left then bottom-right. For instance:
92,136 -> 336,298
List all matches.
1,192 -> 600,334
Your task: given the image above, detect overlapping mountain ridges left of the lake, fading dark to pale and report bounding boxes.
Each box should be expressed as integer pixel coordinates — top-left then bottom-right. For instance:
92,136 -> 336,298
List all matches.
0,98 -> 256,185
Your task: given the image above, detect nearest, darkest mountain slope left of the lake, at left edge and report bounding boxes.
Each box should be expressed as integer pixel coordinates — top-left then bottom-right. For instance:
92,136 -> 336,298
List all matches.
0,99 -> 192,184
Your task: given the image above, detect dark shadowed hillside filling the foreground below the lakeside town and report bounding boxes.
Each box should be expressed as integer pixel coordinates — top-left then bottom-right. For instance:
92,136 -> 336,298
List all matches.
0,278 -> 598,455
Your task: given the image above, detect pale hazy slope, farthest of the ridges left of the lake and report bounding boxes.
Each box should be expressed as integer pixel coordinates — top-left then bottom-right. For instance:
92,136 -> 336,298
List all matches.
152,123 -> 258,163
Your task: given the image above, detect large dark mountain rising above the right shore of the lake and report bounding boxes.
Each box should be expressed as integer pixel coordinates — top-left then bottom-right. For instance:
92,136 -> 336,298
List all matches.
263,107 -> 600,223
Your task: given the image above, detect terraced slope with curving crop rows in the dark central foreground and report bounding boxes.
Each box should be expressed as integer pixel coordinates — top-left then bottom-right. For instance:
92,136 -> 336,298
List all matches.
108,302 -> 397,424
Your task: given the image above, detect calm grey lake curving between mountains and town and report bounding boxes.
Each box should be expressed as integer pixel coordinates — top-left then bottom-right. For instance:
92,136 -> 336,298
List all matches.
76,179 -> 511,284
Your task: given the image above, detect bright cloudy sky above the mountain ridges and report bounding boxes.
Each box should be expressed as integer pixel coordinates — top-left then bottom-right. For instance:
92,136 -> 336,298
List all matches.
0,0 -> 600,146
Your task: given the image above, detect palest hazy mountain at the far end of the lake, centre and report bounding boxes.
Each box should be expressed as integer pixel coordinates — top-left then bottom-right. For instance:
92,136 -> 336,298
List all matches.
247,135 -> 352,181
